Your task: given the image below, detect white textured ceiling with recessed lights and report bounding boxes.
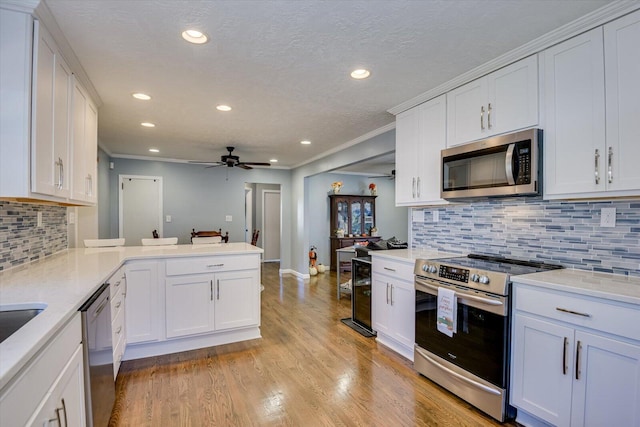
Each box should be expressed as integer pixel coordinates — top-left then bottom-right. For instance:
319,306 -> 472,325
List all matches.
45,0 -> 607,171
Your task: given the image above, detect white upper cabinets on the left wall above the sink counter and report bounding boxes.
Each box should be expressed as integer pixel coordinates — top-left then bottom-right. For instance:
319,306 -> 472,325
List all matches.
0,4 -> 98,205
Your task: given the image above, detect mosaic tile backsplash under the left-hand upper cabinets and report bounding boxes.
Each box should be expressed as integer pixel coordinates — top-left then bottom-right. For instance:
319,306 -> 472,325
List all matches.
0,201 -> 67,270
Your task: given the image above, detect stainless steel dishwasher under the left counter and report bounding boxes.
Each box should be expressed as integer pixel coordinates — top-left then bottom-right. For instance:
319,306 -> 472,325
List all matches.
80,283 -> 116,427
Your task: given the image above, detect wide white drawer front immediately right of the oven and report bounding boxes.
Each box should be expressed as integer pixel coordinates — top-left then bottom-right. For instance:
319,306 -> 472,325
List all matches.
513,283 -> 640,340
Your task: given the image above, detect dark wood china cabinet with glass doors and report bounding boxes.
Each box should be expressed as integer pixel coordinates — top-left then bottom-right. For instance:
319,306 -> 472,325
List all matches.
329,194 -> 380,271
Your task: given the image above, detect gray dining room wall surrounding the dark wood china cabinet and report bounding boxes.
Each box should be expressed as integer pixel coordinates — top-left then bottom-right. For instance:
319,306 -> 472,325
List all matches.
306,173 -> 409,265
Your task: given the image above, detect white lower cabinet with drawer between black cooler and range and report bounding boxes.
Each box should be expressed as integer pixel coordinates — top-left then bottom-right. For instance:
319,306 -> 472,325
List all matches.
371,257 -> 416,360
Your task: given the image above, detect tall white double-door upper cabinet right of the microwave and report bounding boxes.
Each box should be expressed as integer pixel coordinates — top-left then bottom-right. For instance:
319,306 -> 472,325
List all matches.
542,12 -> 640,199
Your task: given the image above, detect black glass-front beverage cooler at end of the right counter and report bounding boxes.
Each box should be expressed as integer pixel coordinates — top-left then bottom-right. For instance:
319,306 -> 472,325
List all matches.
342,248 -> 375,337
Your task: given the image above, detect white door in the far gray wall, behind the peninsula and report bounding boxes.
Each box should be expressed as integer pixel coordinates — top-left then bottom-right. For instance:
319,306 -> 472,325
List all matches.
119,175 -> 162,246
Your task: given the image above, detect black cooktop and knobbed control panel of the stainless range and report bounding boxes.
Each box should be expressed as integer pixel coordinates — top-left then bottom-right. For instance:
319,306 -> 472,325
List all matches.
415,254 -> 563,295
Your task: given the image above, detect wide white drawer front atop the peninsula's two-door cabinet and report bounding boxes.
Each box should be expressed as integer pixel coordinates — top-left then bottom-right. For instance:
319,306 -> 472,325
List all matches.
166,255 -> 260,276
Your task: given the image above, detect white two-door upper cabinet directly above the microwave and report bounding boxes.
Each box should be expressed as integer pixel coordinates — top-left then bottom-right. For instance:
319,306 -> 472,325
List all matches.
447,55 -> 538,147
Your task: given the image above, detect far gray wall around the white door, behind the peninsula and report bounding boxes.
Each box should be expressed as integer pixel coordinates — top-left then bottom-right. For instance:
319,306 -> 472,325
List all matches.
109,158 -> 291,252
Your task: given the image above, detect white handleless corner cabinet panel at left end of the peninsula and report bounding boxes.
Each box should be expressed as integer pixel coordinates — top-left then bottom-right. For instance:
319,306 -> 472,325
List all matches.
125,261 -> 164,344
